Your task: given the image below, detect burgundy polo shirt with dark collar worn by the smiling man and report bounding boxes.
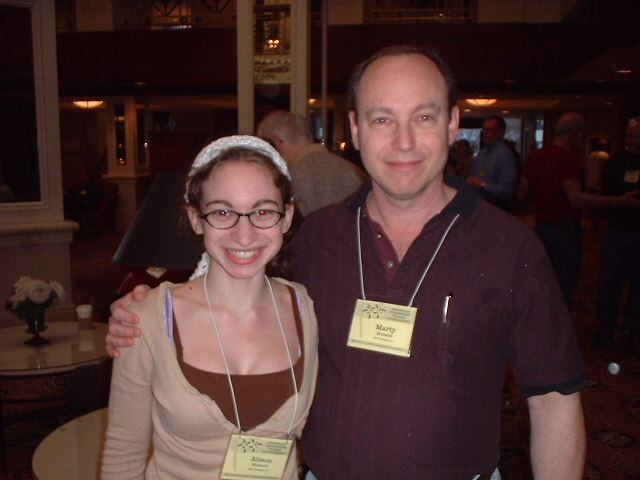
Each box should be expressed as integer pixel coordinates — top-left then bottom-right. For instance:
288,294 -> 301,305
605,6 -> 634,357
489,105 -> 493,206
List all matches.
292,178 -> 586,480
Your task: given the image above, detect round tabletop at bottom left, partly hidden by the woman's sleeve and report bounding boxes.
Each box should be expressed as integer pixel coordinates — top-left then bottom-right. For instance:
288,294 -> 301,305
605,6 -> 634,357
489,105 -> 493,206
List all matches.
31,408 -> 108,480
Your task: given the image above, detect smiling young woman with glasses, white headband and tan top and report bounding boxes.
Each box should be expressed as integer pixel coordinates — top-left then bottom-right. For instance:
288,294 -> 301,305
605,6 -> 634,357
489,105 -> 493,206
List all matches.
102,136 -> 317,480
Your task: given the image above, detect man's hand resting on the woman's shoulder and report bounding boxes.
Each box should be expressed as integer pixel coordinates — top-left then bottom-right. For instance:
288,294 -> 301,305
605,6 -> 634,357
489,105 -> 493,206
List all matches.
106,285 -> 151,358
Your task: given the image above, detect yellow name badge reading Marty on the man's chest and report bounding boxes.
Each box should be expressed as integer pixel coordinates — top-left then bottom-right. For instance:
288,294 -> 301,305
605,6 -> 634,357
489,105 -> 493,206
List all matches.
347,299 -> 418,357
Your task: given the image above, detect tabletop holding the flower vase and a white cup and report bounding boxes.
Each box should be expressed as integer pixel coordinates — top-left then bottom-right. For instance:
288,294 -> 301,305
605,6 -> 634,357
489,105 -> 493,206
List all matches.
0,322 -> 108,376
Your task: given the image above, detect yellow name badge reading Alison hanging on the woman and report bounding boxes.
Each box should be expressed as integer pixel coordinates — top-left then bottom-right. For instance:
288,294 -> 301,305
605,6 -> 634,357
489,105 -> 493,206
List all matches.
220,433 -> 293,480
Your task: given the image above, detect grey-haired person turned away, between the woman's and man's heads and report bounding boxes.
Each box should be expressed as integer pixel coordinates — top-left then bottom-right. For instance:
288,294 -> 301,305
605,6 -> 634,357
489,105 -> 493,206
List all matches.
257,110 -> 368,217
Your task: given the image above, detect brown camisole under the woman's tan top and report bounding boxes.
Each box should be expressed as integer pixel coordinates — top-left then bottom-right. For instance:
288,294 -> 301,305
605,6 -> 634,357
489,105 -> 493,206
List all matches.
173,287 -> 304,431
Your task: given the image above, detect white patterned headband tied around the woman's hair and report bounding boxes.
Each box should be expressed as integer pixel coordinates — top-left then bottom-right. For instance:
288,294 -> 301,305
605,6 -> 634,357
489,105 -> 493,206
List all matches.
184,135 -> 291,280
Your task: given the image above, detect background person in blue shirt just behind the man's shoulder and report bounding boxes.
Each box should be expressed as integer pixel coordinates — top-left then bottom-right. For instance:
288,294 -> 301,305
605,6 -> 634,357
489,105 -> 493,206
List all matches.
467,115 -> 518,210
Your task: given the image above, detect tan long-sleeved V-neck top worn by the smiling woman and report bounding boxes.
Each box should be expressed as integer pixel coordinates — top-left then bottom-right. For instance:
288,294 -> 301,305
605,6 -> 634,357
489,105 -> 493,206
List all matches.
101,279 -> 318,480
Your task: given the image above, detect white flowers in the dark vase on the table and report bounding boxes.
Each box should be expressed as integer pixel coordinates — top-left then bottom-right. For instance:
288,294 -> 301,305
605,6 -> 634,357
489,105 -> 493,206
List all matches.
5,277 -> 64,318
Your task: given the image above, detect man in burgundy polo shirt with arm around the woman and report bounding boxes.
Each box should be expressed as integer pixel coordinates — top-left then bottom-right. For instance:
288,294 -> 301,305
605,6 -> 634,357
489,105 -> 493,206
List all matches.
107,46 -> 587,480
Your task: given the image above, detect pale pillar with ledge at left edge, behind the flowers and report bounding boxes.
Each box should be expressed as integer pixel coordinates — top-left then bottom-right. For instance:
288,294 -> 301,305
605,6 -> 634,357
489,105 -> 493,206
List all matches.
0,0 -> 78,325
